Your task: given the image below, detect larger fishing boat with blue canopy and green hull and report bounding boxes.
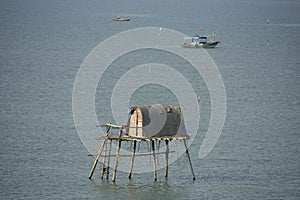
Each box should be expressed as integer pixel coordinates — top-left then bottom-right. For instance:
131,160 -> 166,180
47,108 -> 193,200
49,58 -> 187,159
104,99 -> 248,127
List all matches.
183,34 -> 220,48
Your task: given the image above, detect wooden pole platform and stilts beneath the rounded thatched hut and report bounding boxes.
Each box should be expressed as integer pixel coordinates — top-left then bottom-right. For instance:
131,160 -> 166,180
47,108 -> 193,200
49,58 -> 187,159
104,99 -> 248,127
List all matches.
89,124 -> 196,182
